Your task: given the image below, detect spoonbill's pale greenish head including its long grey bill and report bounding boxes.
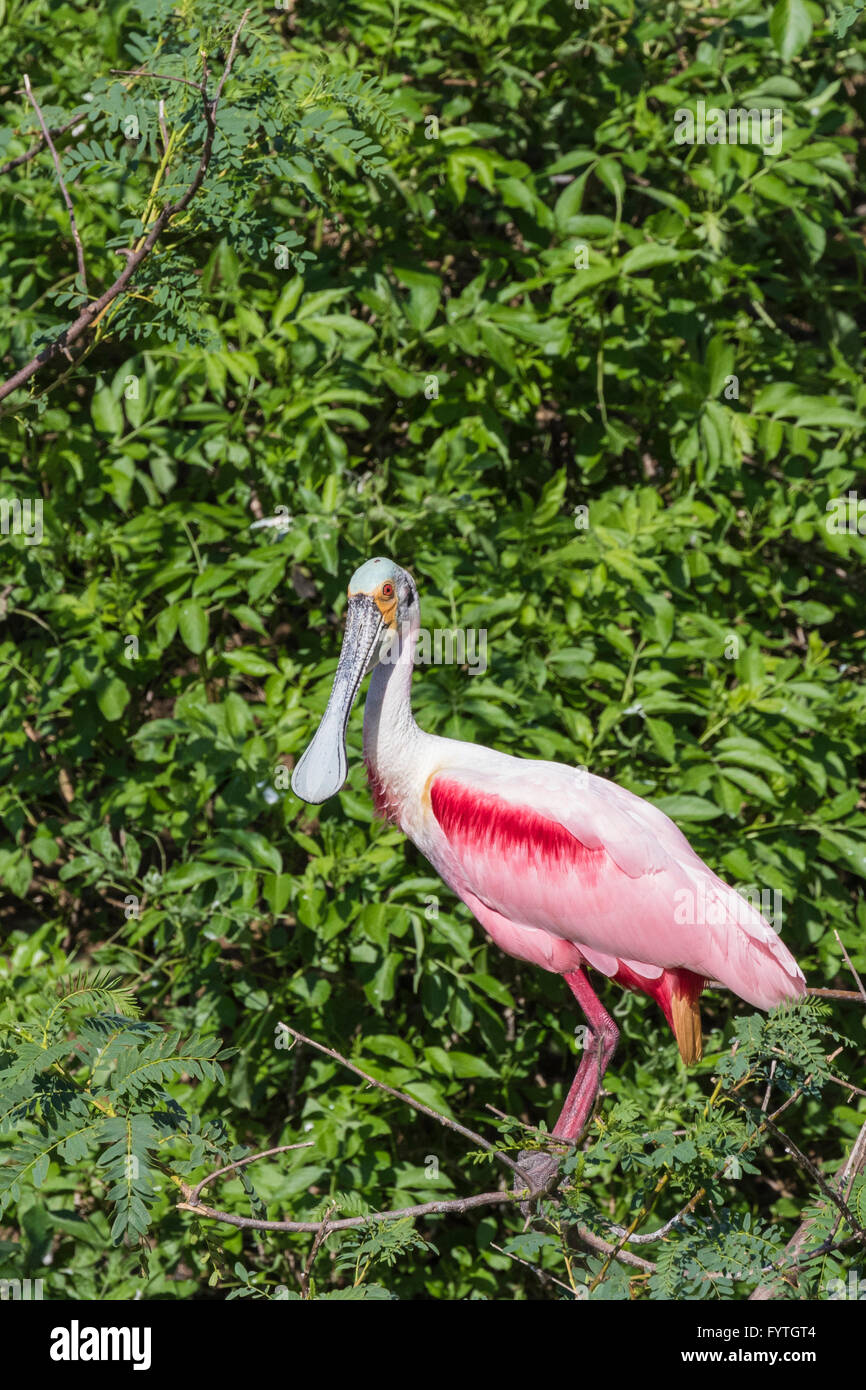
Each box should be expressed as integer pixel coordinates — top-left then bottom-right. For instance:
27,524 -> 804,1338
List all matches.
292,556 -> 418,805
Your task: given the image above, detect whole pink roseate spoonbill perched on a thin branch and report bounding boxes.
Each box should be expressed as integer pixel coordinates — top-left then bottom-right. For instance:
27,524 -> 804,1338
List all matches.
292,557 -> 805,1180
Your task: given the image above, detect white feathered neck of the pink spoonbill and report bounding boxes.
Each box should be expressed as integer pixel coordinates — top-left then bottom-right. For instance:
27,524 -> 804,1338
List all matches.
364,617 -> 421,817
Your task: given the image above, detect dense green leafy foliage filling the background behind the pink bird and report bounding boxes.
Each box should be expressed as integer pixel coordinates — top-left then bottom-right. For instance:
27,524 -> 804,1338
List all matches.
0,0 -> 866,1300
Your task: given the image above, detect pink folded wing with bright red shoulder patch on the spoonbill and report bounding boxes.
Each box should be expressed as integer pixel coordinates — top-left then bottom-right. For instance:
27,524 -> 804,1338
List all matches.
424,759 -> 805,1009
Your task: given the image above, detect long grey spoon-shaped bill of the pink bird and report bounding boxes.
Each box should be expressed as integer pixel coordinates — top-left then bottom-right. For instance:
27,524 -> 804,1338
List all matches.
292,594 -> 384,805
